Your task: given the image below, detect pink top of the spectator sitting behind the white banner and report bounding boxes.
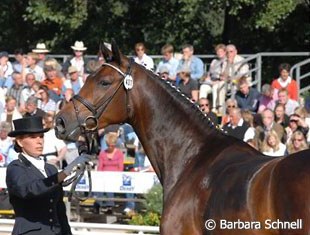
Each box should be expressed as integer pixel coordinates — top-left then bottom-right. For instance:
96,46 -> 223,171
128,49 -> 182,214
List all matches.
97,149 -> 124,171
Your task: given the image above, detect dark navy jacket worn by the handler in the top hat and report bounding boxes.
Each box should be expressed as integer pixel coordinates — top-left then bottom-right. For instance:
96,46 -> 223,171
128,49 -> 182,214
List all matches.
6,154 -> 72,235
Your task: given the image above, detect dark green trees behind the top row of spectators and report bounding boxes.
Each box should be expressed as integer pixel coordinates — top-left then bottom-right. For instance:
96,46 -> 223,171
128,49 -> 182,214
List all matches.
0,0 -> 310,54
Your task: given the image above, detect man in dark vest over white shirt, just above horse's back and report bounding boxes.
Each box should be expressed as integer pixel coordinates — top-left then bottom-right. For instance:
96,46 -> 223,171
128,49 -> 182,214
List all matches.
223,108 -> 253,140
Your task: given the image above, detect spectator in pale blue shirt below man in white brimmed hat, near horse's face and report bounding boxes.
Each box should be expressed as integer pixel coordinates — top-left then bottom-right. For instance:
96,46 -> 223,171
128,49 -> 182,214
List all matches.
62,66 -> 84,95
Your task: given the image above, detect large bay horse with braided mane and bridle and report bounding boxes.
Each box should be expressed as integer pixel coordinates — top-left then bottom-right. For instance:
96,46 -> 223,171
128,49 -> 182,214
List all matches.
55,42 -> 310,235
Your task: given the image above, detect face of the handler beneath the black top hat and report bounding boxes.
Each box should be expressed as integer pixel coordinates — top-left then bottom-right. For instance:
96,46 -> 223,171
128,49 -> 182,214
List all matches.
16,133 -> 44,157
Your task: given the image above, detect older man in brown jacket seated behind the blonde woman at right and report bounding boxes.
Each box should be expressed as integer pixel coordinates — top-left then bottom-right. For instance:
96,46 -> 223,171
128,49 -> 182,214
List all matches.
255,109 -> 286,149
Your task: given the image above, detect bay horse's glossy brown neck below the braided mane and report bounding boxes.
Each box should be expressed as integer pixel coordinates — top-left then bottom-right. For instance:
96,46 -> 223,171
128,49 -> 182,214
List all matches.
131,75 -> 217,191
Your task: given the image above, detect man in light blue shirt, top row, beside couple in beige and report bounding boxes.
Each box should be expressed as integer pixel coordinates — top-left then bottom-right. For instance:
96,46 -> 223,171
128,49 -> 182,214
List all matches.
177,44 -> 204,81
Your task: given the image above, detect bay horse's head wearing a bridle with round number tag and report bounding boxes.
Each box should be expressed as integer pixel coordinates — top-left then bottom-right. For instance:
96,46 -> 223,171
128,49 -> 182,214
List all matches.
55,41 -> 133,141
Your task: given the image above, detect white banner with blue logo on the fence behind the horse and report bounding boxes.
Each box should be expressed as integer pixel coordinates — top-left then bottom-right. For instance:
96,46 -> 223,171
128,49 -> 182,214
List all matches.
0,167 -> 159,193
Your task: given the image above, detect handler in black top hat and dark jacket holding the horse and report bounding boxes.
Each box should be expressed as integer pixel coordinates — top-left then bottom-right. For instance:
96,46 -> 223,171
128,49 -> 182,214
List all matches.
6,117 -> 90,235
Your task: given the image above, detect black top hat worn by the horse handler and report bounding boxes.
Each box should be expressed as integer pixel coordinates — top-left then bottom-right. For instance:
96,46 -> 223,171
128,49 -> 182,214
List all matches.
8,117 -> 49,137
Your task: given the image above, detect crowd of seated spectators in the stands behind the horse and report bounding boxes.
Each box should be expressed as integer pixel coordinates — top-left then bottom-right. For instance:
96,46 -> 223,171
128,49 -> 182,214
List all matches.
0,41 -> 310,215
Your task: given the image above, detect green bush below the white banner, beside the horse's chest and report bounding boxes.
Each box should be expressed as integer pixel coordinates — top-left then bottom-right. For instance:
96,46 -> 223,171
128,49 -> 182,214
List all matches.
129,184 -> 163,226
